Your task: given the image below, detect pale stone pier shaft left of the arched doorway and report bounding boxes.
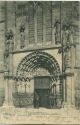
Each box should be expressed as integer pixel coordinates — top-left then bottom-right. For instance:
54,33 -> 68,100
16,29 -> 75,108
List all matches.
3,51 -> 14,107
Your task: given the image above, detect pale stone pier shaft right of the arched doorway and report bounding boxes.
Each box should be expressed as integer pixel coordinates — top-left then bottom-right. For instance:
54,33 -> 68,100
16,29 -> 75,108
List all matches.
66,46 -> 75,107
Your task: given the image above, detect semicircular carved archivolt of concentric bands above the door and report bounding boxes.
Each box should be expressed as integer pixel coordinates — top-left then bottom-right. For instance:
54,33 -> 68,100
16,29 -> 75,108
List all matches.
16,51 -> 61,81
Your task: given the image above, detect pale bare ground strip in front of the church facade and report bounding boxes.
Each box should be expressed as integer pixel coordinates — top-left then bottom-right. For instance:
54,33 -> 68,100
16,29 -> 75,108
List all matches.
0,107 -> 80,124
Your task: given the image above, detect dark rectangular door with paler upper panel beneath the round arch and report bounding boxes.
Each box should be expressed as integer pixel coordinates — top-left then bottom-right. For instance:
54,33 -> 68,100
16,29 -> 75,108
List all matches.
34,76 -> 50,108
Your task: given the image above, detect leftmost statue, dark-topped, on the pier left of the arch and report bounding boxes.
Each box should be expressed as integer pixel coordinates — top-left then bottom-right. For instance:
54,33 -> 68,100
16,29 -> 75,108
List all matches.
5,29 -> 14,52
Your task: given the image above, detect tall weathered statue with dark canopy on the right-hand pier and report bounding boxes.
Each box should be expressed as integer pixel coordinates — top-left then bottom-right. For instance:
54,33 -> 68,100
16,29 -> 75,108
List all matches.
62,25 -> 73,68
